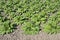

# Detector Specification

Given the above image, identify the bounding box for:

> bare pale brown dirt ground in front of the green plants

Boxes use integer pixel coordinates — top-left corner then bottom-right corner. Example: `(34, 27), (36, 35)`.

(0, 26), (60, 40)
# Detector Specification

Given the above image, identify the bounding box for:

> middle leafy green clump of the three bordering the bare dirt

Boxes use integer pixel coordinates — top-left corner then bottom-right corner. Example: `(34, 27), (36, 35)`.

(22, 22), (39, 35)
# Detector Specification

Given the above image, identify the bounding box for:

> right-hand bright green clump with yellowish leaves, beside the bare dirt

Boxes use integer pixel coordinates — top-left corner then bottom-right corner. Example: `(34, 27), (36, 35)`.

(43, 12), (60, 34)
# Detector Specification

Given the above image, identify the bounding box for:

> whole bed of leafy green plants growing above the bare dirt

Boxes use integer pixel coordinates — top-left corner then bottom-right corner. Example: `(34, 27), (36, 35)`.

(0, 0), (60, 34)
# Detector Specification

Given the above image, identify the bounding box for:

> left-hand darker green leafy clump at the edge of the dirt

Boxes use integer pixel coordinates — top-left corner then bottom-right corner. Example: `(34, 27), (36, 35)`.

(0, 17), (14, 34)
